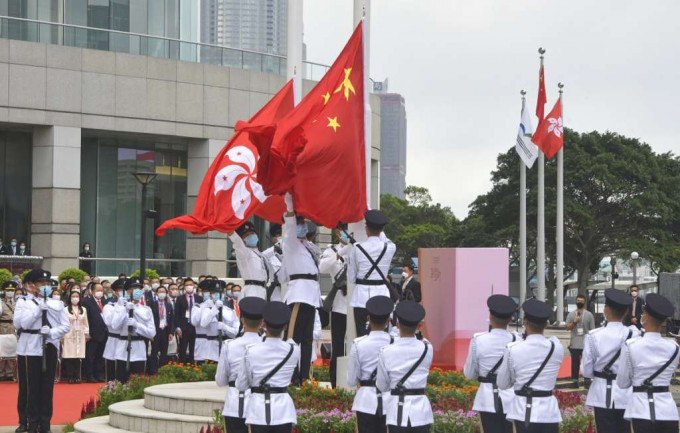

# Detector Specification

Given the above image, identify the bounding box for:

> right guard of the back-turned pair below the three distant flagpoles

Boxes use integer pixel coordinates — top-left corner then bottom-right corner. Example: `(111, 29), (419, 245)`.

(496, 299), (564, 433)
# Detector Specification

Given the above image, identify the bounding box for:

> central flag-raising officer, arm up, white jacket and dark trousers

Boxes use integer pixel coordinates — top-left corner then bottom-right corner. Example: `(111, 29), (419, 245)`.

(283, 193), (321, 383)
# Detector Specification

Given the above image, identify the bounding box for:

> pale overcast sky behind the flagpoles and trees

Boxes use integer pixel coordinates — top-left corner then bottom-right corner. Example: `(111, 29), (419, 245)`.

(304, 0), (680, 218)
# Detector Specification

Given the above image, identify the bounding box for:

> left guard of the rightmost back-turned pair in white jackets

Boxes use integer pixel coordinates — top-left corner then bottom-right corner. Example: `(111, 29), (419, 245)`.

(581, 289), (639, 433)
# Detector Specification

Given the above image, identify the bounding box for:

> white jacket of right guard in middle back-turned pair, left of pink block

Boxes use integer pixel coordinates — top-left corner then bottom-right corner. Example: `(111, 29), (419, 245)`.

(376, 337), (434, 427)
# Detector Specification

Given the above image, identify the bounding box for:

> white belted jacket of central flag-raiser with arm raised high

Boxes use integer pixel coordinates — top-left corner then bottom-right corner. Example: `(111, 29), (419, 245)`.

(282, 216), (321, 308)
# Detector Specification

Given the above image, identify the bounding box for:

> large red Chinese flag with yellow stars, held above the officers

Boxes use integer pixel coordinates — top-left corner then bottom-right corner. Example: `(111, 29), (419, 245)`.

(236, 24), (366, 227)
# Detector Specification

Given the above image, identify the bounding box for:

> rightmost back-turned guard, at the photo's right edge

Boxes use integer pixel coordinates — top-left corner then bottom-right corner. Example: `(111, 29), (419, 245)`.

(616, 293), (679, 433)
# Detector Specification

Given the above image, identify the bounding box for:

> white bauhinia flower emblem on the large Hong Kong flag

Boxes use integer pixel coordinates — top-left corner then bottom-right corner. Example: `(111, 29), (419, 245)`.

(214, 146), (267, 219)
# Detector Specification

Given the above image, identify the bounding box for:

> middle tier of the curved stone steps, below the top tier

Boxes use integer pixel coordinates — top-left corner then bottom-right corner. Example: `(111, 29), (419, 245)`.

(109, 400), (214, 433)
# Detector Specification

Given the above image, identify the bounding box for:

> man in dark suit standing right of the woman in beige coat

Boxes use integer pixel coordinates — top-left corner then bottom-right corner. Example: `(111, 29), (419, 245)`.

(82, 283), (108, 382)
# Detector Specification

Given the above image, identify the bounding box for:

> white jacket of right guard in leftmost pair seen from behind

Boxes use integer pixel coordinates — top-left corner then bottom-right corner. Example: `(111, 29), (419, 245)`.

(236, 338), (300, 425)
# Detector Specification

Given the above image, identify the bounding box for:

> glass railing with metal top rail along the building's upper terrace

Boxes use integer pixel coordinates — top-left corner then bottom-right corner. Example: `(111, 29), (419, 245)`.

(0, 15), (329, 81)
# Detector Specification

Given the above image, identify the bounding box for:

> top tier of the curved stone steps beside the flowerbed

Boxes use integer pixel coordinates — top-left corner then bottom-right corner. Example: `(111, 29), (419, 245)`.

(144, 382), (227, 417)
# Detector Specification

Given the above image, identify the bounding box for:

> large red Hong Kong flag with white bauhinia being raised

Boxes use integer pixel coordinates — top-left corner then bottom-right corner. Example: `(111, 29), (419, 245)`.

(156, 80), (293, 236)
